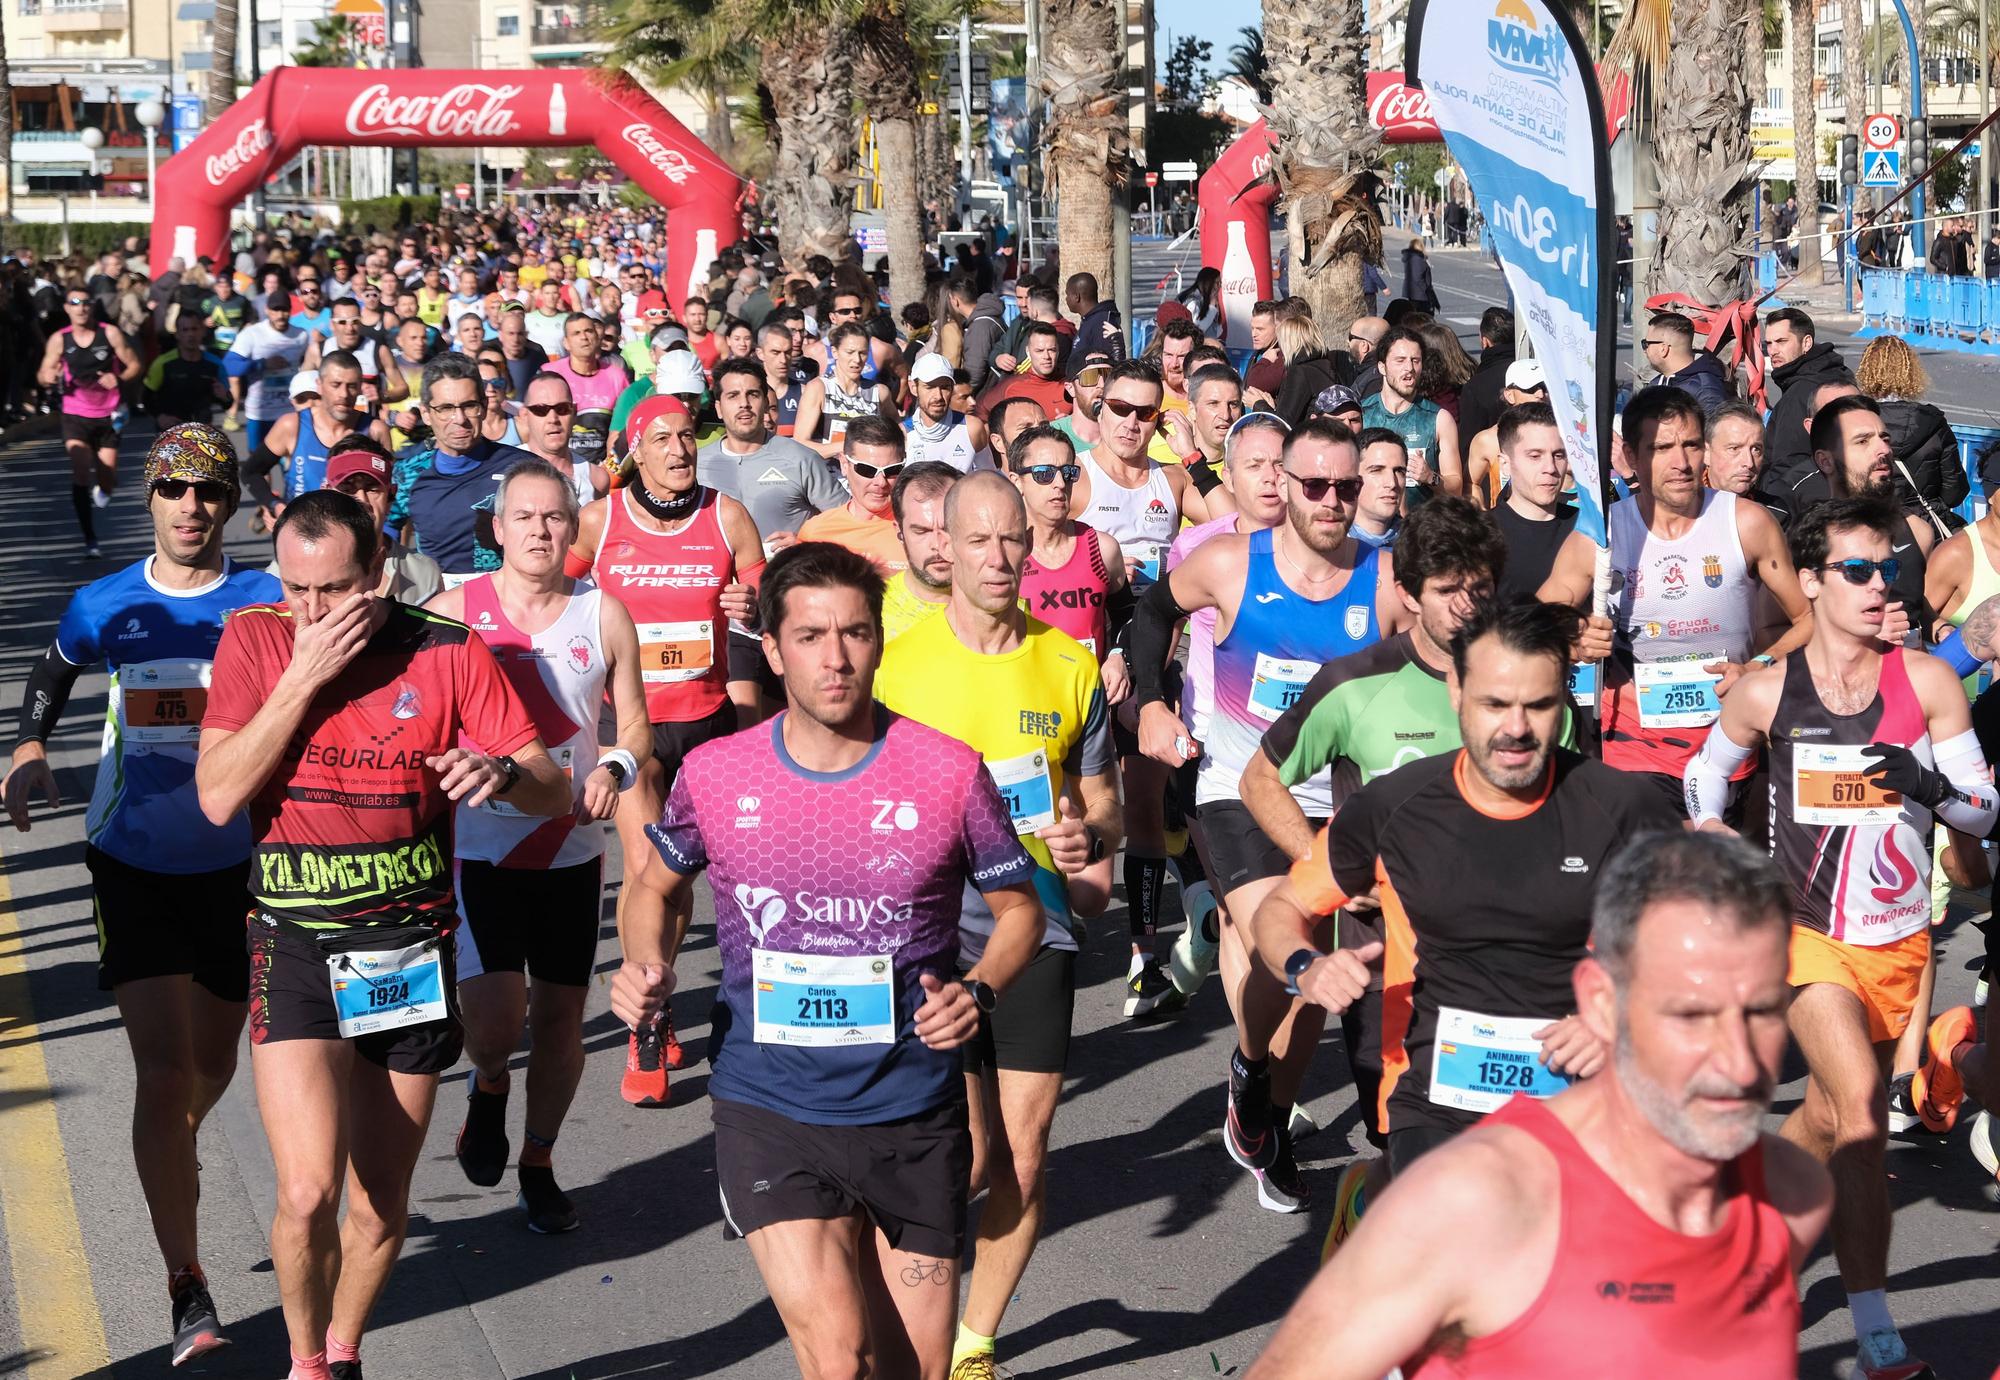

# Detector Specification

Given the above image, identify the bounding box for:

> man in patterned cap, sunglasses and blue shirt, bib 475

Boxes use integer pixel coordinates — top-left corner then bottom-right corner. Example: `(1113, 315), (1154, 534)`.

(4, 422), (280, 1366)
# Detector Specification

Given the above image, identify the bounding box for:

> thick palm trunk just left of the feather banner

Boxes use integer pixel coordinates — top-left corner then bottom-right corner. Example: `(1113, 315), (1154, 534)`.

(1264, 0), (1382, 340)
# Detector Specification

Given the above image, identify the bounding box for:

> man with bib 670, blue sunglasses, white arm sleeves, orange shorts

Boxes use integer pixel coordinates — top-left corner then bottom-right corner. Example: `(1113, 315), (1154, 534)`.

(1684, 494), (2000, 1380)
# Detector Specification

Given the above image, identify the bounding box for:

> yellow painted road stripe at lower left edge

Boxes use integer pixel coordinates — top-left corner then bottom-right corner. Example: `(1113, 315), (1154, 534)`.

(0, 844), (112, 1380)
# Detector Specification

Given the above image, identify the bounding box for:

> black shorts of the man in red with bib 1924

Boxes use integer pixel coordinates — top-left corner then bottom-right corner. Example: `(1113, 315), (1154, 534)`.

(250, 914), (466, 1074)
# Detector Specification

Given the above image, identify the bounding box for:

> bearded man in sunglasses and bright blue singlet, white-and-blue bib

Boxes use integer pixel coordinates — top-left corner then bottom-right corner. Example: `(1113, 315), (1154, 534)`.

(1130, 420), (1414, 1212)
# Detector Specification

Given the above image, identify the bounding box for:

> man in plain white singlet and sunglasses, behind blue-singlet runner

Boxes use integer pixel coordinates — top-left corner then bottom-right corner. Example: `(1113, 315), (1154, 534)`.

(1070, 360), (1194, 1018)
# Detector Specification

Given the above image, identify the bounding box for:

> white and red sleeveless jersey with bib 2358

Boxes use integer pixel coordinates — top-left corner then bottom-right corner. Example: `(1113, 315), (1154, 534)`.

(1604, 490), (1756, 776)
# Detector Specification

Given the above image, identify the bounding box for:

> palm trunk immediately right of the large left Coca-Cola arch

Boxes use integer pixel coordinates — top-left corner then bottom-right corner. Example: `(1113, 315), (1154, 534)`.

(760, 24), (856, 264)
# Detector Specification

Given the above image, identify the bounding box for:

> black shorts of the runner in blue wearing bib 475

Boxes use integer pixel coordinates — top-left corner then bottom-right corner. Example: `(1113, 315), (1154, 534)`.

(84, 844), (250, 1002)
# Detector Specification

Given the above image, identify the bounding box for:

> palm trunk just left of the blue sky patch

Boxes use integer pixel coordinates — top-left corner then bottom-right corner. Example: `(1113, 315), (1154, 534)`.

(1042, 0), (1132, 296)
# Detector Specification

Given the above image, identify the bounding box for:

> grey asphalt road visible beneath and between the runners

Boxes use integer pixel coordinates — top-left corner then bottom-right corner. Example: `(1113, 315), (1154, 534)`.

(0, 392), (2000, 1380)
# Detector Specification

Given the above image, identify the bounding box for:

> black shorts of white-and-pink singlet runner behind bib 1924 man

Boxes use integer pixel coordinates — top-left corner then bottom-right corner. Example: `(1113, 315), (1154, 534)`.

(458, 858), (604, 988)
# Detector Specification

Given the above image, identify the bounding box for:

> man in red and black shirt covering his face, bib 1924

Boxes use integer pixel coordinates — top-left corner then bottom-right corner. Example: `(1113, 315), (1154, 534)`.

(194, 490), (572, 1380)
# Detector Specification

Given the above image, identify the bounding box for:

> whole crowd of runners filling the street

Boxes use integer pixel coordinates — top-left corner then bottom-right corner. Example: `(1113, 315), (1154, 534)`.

(6, 212), (2000, 1380)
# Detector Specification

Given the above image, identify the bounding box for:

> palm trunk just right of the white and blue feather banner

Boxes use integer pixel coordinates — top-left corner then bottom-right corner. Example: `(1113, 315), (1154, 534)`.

(1646, 0), (1762, 306)
